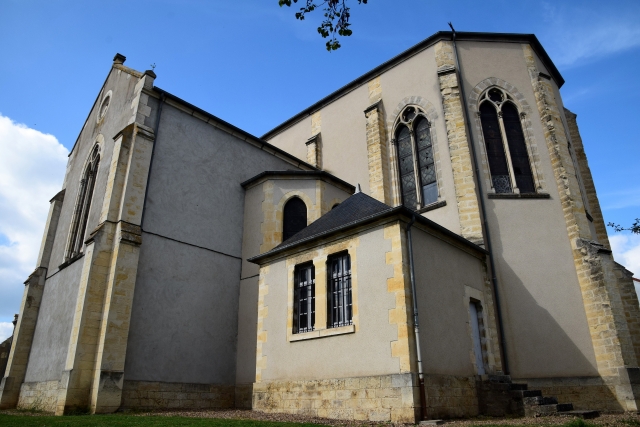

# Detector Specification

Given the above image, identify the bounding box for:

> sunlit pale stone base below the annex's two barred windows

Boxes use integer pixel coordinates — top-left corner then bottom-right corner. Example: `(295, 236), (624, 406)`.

(253, 373), (420, 423)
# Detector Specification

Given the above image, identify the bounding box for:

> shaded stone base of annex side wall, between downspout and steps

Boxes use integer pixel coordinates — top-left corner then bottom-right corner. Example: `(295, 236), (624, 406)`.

(424, 375), (479, 419)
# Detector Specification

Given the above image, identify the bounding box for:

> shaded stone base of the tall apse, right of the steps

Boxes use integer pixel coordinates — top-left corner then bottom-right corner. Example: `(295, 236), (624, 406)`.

(514, 377), (625, 412)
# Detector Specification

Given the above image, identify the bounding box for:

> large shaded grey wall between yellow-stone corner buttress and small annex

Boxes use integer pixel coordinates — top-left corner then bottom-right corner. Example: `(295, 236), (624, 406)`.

(123, 102), (304, 402)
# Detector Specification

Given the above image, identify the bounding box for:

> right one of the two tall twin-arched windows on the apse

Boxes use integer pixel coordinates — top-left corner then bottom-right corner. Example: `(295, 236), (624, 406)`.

(479, 88), (536, 193)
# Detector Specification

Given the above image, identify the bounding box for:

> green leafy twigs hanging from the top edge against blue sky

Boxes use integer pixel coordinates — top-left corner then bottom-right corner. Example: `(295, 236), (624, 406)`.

(278, 0), (368, 52)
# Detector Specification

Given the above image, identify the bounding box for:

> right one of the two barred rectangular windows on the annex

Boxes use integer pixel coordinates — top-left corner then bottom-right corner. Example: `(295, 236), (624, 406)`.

(327, 253), (353, 328)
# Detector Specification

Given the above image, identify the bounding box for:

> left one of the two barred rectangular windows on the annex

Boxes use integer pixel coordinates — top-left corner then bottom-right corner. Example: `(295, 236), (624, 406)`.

(293, 264), (316, 334)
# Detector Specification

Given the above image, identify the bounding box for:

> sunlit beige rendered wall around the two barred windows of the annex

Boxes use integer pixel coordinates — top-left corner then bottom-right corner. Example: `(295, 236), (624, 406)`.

(261, 227), (400, 382)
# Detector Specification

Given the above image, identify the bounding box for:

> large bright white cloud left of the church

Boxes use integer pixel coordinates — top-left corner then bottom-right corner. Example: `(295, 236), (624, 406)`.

(0, 114), (69, 320)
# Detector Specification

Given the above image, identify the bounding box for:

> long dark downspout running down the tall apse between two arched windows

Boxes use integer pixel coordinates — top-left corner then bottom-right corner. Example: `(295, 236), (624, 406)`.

(449, 22), (509, 375)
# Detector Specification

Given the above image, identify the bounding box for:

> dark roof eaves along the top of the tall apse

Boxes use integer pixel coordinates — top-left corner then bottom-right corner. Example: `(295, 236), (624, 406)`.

(261, 31), (564, 139)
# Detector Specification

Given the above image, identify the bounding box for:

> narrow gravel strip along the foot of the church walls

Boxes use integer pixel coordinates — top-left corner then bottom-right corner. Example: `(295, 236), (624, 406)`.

(0, 410), (640, 427)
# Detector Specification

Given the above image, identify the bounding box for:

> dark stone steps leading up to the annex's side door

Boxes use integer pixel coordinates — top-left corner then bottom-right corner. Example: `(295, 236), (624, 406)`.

(477, 375), (600, 419)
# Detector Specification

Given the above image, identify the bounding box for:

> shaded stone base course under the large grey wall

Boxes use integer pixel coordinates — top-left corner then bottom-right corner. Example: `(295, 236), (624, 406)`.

(121, 380), (236, 409)
